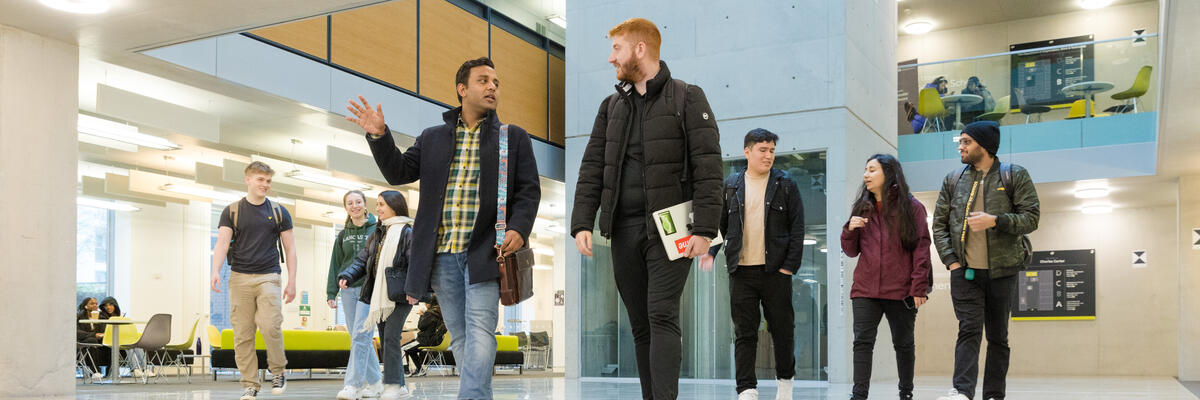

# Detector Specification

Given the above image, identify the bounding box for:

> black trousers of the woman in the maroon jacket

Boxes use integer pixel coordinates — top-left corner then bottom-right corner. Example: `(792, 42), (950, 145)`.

(850, 297), (917, 400)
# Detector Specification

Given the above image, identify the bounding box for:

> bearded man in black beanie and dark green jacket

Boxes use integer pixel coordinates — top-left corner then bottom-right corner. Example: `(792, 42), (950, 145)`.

(934, 121), (1040, 400)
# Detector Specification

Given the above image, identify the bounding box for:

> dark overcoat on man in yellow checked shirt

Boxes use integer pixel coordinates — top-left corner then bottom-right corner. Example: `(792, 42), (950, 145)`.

(367, 107), (541, 299)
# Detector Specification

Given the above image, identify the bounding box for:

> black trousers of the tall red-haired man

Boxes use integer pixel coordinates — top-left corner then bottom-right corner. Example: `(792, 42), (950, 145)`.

(612, 222), (691, 400)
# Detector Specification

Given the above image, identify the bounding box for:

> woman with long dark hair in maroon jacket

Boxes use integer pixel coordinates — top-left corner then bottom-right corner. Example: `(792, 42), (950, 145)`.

(841, 154), (931, 399)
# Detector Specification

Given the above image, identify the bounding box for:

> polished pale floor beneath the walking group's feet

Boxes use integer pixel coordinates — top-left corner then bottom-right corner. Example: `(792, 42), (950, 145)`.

(77, 374), (1200, 400)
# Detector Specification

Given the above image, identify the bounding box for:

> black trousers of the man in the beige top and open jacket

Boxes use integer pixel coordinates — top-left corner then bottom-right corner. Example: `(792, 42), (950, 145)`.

(730, 265), (796, 393)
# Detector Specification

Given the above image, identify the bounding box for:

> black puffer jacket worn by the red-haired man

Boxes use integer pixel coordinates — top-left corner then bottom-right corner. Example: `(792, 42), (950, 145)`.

(571, 61), (722, 238)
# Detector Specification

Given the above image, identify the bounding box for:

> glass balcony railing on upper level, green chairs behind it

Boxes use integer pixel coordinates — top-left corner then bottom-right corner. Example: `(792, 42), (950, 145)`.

(899, 34), (1159, 135)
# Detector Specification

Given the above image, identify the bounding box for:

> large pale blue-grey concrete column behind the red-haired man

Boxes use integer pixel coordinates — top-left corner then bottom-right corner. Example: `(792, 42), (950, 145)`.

(565, 0), (896, 382)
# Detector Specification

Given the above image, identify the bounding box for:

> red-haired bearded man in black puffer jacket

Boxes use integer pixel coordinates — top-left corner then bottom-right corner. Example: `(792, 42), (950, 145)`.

(571, 18), (721, 399)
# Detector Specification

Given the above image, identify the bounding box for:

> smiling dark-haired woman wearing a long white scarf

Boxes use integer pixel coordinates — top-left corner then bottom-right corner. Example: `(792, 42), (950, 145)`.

(337, 190), (416, 400)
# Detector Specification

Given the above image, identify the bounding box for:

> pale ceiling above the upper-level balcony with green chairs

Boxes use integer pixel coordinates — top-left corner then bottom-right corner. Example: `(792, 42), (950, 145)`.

(896, 0), (1154, 35)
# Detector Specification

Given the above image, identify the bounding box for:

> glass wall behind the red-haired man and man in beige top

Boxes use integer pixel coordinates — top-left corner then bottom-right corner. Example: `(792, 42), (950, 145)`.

(581, 151), (828, 380)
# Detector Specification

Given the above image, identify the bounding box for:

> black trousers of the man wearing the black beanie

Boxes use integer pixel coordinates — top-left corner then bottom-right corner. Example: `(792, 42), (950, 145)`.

(950, 264), (1016, 399)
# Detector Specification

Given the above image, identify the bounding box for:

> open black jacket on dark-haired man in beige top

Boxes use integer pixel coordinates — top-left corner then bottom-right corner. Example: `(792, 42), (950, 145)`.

(708, 168), (804, 273)
